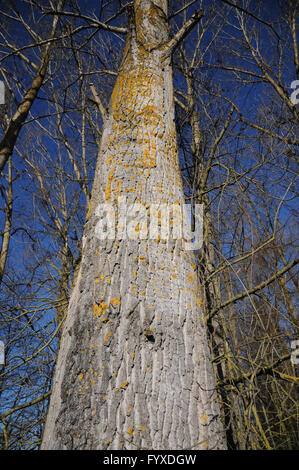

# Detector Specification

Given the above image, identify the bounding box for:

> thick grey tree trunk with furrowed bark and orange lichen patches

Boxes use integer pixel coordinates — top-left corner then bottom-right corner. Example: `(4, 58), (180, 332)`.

(42, 0), (225, 449)
